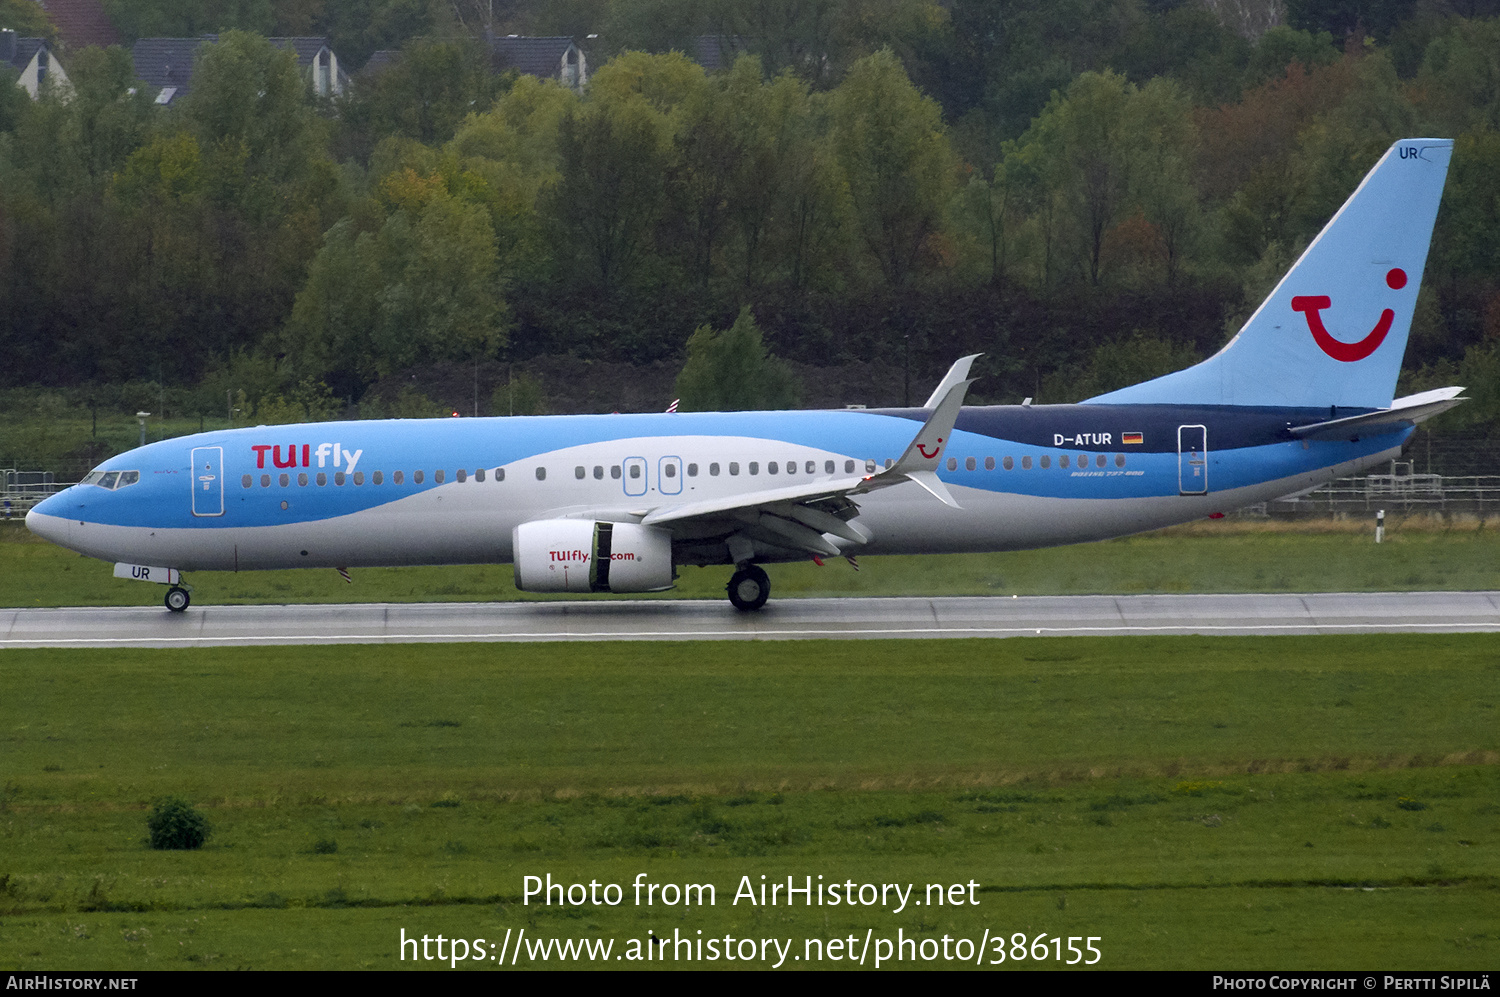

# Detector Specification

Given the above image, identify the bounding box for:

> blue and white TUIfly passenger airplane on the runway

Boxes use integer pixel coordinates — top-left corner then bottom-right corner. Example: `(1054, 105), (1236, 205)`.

(26, 138), (1464, 612)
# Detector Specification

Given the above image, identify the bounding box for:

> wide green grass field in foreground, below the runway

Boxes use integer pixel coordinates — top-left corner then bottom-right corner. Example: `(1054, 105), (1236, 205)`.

(0, 636), (1500, 969)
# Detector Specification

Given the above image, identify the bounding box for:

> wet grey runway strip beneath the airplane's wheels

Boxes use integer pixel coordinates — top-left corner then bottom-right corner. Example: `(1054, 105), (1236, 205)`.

(0, 592), (1500, 648)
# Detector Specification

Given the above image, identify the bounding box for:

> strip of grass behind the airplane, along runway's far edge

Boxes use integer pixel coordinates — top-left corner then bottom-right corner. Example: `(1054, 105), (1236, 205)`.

(0, 517), (1500, 606)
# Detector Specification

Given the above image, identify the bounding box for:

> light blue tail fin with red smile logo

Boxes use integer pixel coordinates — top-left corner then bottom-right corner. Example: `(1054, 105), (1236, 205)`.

(1089, 138), (1454, 408)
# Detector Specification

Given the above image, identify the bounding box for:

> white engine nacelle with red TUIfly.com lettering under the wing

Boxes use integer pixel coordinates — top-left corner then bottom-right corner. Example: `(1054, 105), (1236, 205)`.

(512, 519), (672, 592)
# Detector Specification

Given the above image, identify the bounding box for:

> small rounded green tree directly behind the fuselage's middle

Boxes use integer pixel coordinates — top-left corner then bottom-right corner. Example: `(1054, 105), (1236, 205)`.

(677, 306), (800, 412)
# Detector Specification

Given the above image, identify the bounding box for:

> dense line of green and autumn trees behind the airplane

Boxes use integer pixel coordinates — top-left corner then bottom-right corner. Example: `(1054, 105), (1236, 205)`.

(0, 0), (1500, 440)
